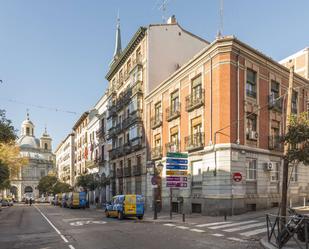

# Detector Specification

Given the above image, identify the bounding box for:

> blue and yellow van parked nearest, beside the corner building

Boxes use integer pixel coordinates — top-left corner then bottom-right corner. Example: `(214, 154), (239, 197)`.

(105, 195), (144, 220)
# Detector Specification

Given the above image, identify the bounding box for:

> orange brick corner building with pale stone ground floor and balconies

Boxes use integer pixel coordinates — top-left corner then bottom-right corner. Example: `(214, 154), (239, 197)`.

(145, 36), (309, 214)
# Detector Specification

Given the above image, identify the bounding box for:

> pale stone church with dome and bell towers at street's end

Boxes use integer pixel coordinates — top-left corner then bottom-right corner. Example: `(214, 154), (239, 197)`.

(10, 113), (55, 201)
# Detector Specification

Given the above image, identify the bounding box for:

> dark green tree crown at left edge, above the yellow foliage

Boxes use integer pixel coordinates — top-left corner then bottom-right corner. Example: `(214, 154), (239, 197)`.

(0, 110), (17, 143)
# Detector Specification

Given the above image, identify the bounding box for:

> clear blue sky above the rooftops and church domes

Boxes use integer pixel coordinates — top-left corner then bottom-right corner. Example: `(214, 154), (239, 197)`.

(0, 0), (309, 148)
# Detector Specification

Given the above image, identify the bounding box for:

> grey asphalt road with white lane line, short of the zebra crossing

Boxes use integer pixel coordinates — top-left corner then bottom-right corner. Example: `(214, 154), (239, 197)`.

(0, 205), (261, 249)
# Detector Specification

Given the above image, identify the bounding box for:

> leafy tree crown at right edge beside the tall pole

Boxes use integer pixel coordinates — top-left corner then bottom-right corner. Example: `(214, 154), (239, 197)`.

(284, 112), (309, 165)
